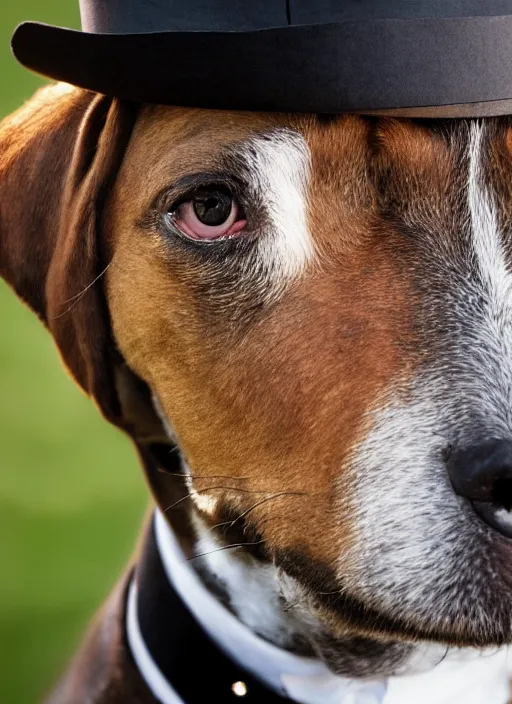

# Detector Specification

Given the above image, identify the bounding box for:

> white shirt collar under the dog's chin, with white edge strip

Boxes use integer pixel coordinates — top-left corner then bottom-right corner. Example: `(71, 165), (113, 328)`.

(127, 512), (508, 704)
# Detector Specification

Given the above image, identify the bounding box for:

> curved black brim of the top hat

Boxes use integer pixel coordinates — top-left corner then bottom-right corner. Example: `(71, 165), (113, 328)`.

(12, 15), (512, 117)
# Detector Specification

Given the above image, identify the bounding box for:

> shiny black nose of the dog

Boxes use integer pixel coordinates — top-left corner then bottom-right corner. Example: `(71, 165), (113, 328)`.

(446, 439), (512, 538)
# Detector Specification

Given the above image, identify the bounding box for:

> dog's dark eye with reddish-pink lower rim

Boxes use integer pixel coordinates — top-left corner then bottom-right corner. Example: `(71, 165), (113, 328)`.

(172, 186), (246, 240)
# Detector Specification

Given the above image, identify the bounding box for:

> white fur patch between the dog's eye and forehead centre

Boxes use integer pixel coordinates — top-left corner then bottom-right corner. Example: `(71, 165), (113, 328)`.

(243, 130), (314, 280)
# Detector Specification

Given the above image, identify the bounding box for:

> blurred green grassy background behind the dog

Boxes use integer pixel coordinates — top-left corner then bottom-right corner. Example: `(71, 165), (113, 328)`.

(0, 0), (148, 704)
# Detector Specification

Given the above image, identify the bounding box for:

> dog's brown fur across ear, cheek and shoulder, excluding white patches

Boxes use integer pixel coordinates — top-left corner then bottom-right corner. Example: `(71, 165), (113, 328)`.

(0, 88), (510, 704)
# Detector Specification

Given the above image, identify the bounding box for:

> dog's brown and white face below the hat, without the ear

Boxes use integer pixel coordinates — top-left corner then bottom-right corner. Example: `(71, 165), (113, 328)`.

(3, 86), (512, 672)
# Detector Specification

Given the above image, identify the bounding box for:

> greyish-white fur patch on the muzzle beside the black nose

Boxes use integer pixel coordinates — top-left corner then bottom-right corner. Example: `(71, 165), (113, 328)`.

(339, 384), (464, 636)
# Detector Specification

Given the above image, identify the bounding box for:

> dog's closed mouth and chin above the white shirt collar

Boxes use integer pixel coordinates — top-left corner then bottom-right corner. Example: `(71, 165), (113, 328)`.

(281, 541), (512, 677)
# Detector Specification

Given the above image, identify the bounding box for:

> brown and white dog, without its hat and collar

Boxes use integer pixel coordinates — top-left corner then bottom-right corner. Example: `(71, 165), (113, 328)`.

(0, 86), (512, 704)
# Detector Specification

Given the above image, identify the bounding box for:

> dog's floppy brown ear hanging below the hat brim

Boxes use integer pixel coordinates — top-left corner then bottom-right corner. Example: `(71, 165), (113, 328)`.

(0, 86), (135, 426)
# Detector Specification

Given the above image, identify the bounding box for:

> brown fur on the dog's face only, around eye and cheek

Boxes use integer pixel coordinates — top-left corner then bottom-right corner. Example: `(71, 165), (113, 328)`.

(102, 108), (418, 576)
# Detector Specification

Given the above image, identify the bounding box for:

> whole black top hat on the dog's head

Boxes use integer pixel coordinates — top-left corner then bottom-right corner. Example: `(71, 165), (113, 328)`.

(12, 0), (512, 117)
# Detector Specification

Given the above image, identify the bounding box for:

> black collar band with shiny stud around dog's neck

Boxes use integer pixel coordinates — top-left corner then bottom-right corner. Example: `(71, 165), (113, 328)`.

(128, 521), (292, 704)
